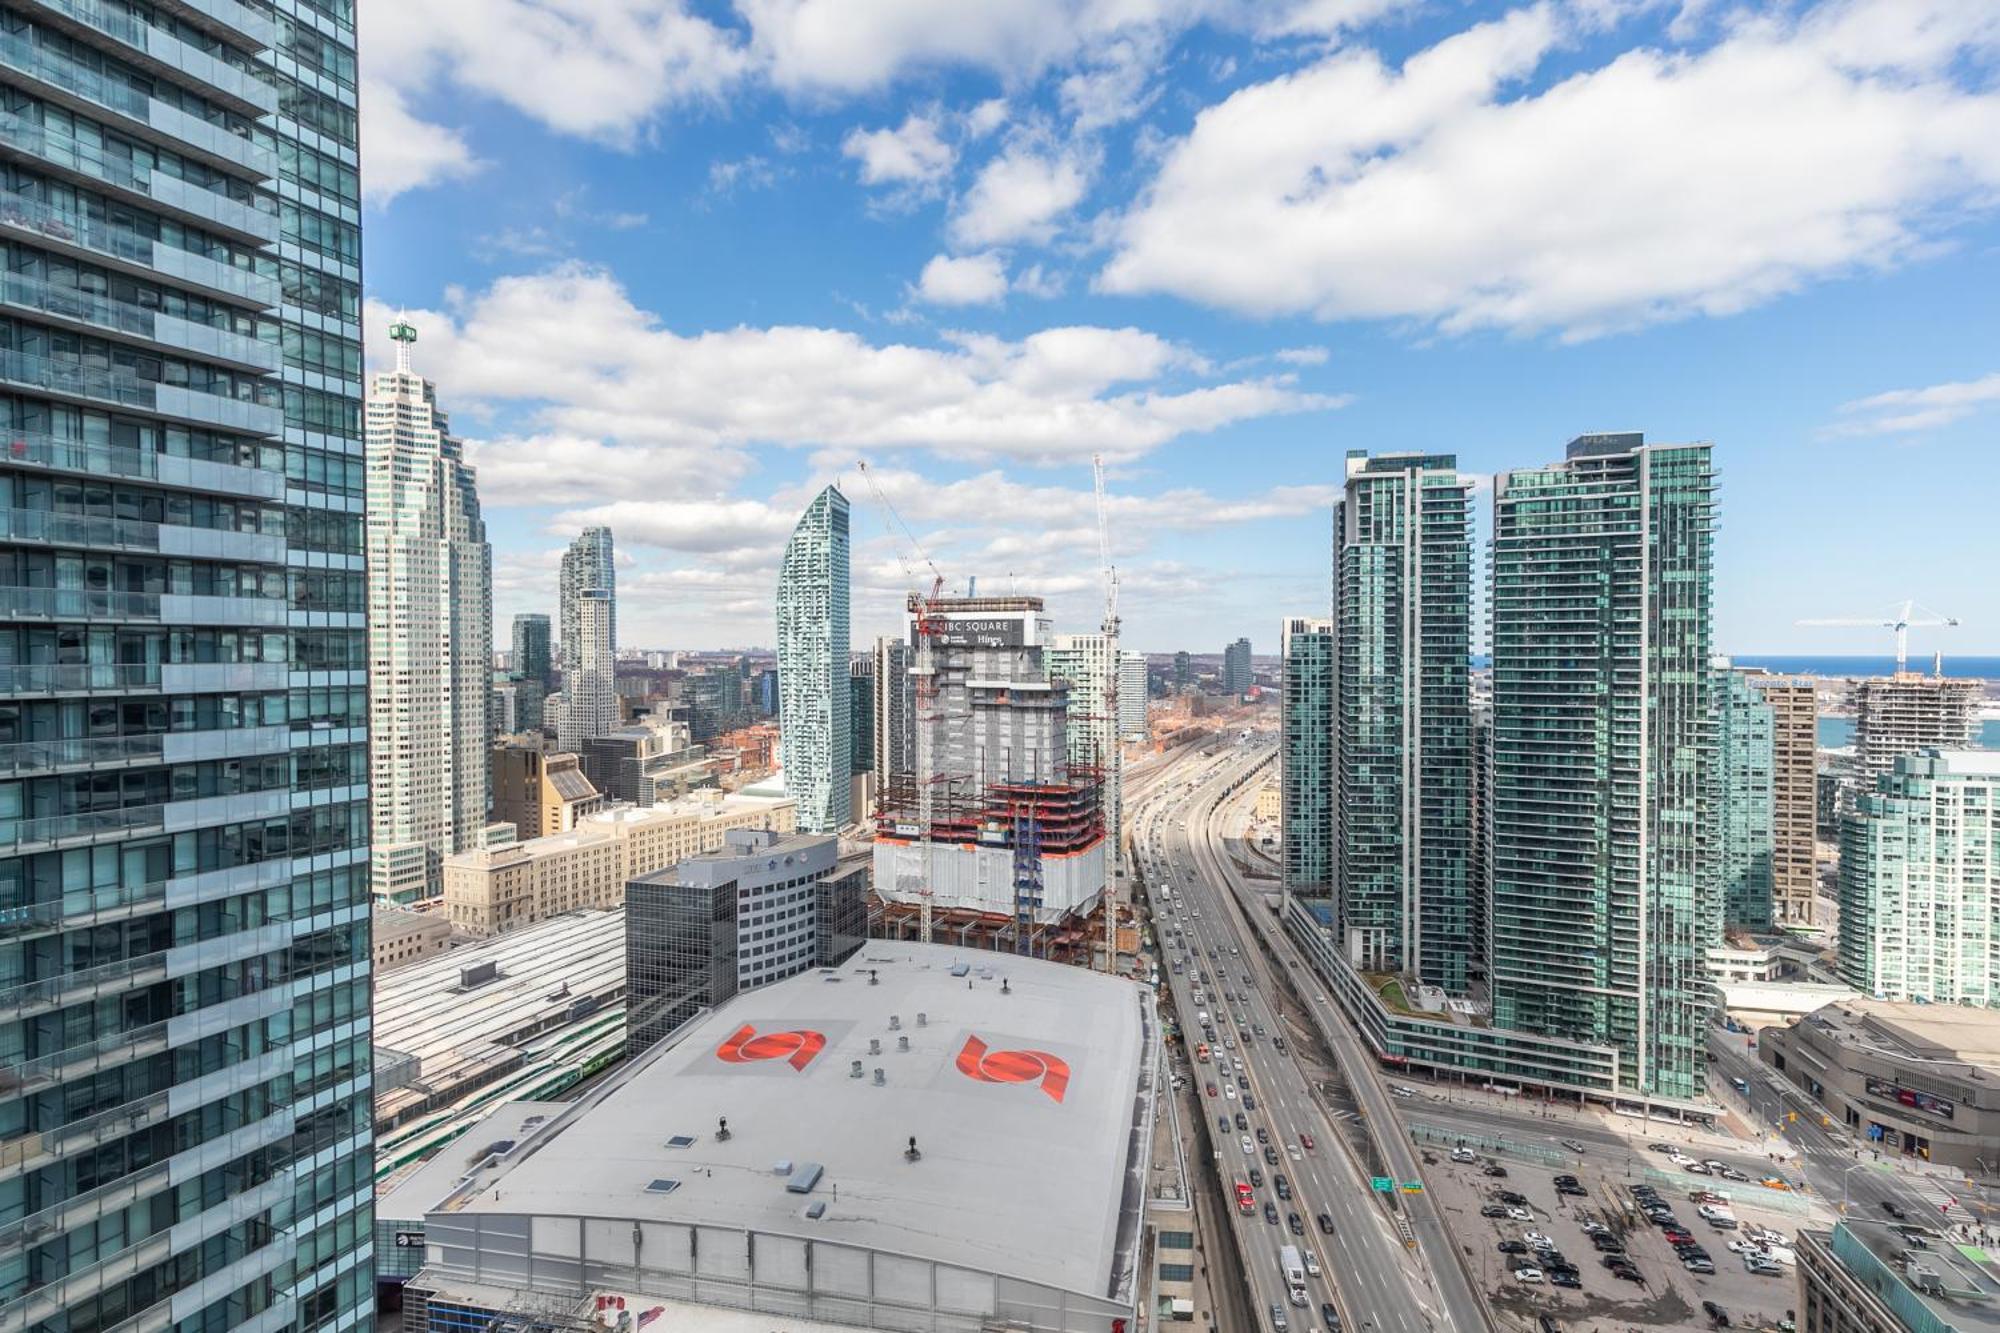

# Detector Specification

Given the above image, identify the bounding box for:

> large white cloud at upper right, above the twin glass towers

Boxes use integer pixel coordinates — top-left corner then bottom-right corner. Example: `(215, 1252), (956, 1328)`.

(1100, 0), (2000, 336)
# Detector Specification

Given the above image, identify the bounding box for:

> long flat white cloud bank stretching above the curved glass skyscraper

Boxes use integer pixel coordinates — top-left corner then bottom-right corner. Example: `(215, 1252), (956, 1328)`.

(366, 264), (1342, 482)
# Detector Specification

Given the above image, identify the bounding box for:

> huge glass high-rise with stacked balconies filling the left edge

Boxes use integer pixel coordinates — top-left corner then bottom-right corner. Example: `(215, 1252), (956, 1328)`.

(0, 0), (374, 1333)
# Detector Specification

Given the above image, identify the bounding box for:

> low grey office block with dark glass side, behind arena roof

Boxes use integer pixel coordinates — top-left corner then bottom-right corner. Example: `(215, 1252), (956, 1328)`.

(626, 829), (868, 1053)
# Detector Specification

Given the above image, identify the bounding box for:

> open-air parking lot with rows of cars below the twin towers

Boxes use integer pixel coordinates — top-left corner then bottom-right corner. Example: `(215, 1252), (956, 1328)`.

(1420, 1139), (1810, 1333)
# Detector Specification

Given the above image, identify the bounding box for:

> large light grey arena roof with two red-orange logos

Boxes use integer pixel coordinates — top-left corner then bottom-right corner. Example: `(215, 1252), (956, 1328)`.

(442, 941), (1156, 1299)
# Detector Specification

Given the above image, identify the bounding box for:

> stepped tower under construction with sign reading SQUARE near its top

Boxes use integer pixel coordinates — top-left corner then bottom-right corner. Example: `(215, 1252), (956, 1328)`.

(874, 594), (1106, 955)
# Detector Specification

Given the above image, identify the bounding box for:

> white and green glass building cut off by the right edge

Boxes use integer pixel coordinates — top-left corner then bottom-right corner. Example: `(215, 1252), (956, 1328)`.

(1840, 751), (2000, 1007)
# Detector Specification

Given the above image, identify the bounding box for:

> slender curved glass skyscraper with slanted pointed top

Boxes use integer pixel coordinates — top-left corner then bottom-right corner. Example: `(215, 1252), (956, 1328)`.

(778, 486), (854, 833)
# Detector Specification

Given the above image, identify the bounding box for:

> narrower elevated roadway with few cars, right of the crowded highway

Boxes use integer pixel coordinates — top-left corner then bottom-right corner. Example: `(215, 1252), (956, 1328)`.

(1190, 747), (1492, 1333)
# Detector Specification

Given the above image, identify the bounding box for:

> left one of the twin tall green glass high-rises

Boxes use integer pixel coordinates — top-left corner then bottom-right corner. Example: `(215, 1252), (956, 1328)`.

(1332, 452), (1476, 995)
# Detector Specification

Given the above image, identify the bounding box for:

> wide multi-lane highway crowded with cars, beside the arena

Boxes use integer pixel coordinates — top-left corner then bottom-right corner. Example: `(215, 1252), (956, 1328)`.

(1128, 747), (1448, 1333)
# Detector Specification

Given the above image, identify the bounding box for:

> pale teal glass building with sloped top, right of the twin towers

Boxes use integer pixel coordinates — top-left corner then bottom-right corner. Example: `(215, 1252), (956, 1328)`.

(1702, 658), (1778, 928)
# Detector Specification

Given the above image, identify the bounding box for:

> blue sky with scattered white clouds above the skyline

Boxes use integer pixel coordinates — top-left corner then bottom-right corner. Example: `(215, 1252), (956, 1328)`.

(358, 0), (2000, 654)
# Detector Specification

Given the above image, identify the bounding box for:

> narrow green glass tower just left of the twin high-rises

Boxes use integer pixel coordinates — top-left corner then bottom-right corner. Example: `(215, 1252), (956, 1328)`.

(1278, 616), (1336, 904)
